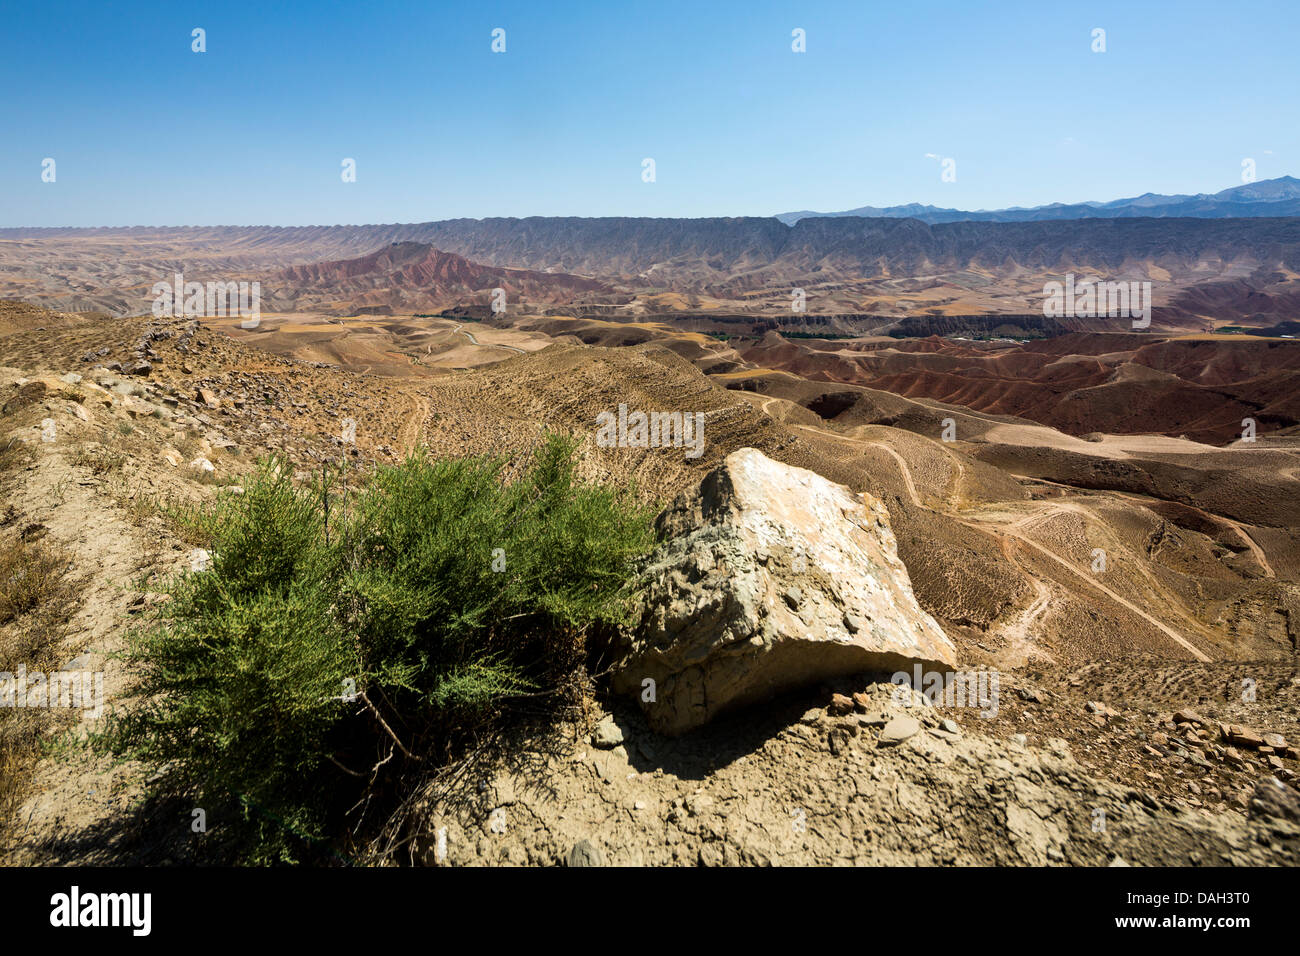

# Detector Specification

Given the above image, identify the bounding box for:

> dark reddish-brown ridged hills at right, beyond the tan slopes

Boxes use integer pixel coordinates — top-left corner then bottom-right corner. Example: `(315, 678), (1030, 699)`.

(736, 333), (1300, 444)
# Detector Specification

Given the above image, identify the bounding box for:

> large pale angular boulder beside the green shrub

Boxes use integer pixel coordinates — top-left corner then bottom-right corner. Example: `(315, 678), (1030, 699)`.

(614, 449), (957, 734)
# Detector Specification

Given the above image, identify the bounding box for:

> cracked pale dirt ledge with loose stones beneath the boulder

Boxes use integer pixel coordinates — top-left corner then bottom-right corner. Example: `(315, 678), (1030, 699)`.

(411, 679), (1300, 866)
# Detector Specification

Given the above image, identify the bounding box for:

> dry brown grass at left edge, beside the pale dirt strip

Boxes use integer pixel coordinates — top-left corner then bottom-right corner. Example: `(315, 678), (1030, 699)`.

(0, 535), (75, 835)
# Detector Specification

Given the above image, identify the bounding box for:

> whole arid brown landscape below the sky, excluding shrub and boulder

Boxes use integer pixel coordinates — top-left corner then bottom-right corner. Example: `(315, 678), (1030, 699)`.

(0, 205), (1300, 865)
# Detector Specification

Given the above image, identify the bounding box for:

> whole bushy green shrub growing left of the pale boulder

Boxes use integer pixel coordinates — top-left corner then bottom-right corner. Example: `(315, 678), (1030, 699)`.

(96, 436), (653, 862)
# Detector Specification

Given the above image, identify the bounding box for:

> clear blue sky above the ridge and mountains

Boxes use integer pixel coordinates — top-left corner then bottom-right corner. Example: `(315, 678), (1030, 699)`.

(0, 0), (1300, 226)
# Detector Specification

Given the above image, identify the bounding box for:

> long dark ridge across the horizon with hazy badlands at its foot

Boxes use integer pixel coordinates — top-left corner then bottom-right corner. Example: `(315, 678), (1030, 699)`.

(10, 216), (1300, 327)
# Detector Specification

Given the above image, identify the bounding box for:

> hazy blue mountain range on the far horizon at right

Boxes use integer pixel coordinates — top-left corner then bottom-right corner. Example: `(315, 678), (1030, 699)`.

(776, 176), (1300, 225)
